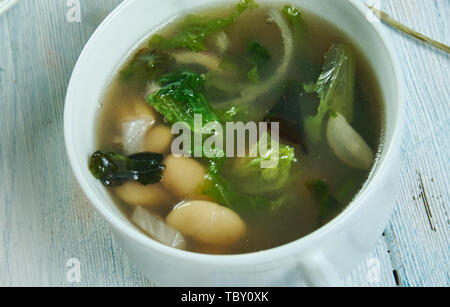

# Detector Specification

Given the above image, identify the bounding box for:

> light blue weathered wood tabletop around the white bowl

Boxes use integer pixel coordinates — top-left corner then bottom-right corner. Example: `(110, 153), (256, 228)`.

(0, 0), (450, 286)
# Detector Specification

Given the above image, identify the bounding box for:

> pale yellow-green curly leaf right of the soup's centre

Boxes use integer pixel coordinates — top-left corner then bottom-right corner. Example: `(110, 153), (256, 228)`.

(233, 134), (296, 194)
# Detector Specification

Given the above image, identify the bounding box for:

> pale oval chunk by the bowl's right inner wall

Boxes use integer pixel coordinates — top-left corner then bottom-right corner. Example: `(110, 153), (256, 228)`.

(327, 113), (375, 170)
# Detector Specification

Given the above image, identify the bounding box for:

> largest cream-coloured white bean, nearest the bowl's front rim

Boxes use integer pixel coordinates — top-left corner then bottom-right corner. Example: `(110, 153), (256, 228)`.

(167, 201), (246, 247)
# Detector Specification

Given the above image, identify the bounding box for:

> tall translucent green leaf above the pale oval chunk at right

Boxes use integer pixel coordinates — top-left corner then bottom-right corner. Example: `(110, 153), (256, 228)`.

(305, 44), (356, 142)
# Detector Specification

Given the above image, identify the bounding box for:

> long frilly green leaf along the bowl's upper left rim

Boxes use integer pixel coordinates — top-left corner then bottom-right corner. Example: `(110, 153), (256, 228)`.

(149, 0), (257, 51)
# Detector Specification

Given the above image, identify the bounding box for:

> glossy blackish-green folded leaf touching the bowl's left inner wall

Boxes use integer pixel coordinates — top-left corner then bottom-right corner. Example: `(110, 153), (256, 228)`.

(89, 150), (165, 186)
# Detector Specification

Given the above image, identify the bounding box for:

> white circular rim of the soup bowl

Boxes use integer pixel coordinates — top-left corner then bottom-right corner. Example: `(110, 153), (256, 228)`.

(64, 0), (404, 267)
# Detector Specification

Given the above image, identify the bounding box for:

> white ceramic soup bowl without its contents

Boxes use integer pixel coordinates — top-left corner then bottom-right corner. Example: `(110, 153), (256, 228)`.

(64, 0), (404, 286)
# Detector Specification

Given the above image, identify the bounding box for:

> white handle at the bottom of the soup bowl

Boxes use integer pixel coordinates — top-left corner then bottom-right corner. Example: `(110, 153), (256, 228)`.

(300, 251), (344, 287)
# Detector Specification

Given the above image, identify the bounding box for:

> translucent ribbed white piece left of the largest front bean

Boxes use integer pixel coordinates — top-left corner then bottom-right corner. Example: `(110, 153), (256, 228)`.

(131, 207), (186, 249)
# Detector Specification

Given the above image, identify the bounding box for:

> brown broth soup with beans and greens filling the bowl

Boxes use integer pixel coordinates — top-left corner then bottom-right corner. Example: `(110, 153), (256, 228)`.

(89, 0), (383, 254)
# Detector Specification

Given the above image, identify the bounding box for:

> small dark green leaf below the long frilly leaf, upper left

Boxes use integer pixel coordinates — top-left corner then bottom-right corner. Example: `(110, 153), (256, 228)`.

(120, 48), (169, 81)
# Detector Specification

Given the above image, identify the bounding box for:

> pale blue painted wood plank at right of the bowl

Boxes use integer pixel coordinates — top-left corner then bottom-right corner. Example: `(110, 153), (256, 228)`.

(358, 0), (450, 286)
